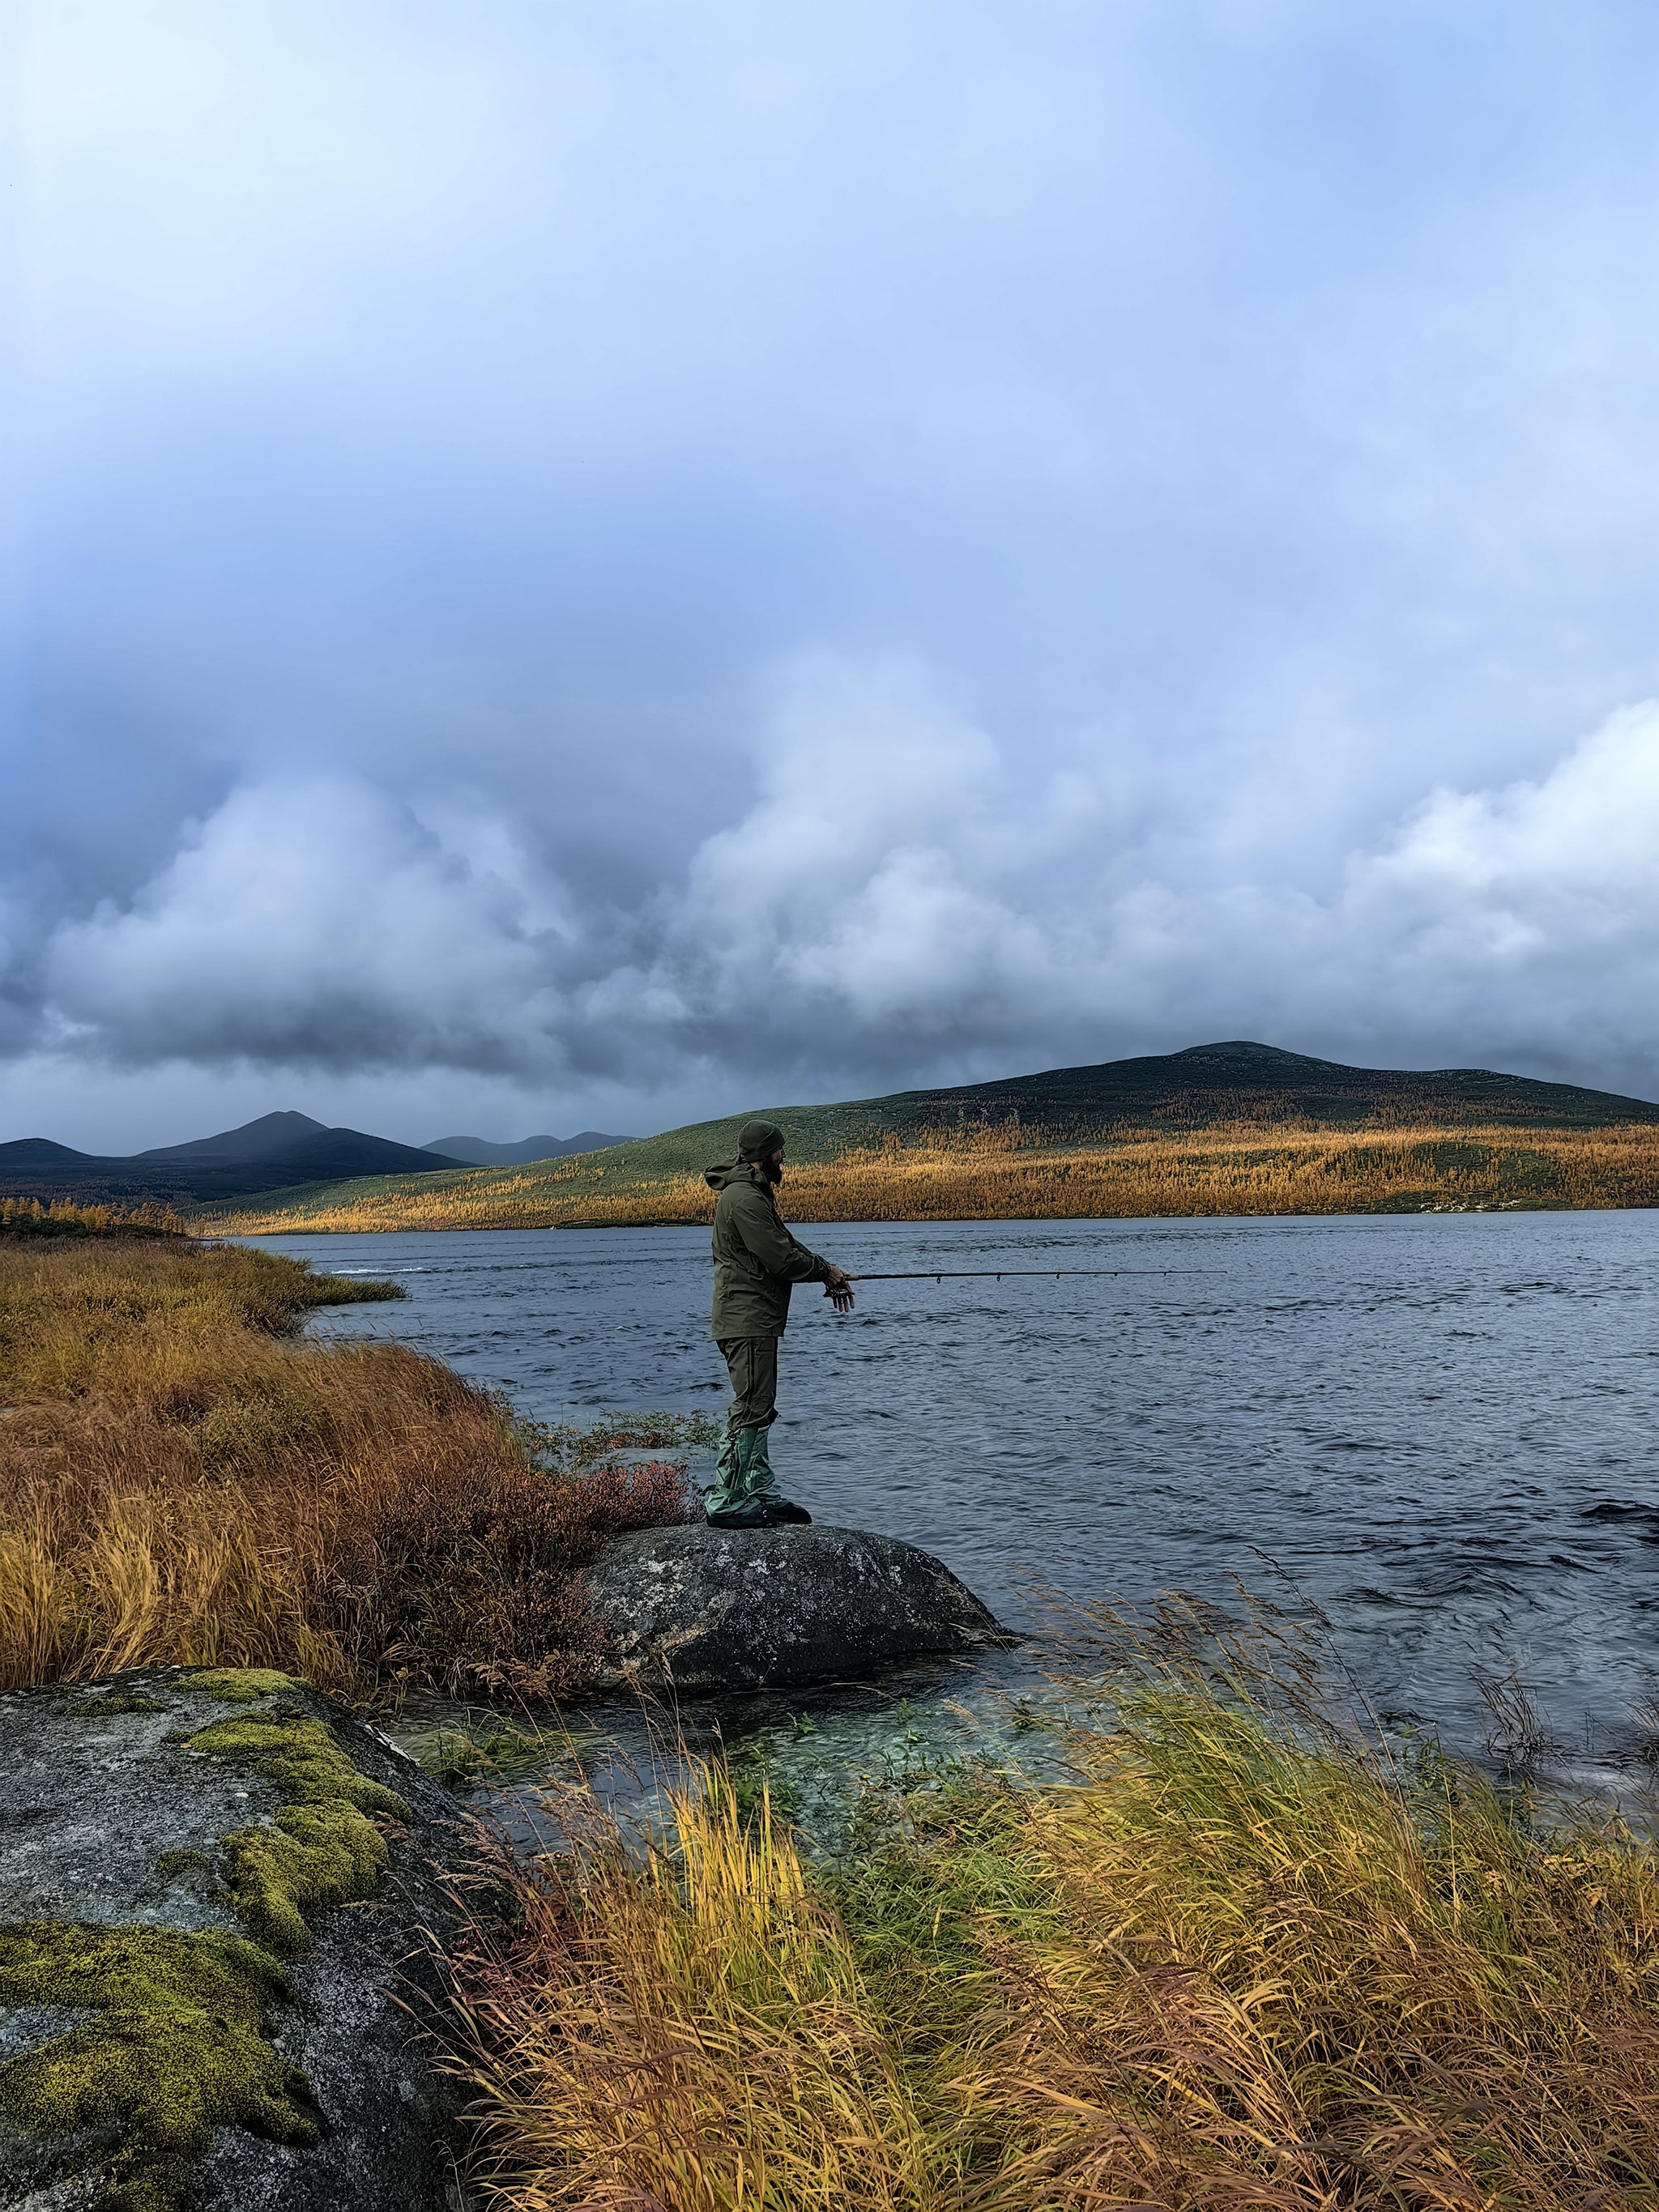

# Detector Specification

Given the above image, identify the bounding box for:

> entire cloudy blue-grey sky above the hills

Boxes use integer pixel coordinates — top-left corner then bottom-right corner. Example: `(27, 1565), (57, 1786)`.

(0, 0), (1659, 1150)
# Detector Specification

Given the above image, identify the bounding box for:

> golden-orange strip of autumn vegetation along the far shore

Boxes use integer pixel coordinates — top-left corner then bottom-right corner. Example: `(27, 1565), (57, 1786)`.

(203, 1123), (1659, 1237)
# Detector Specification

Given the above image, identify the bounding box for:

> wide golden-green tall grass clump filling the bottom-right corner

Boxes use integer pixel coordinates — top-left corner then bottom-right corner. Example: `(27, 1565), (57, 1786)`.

(928, 1619), (1659, 2212)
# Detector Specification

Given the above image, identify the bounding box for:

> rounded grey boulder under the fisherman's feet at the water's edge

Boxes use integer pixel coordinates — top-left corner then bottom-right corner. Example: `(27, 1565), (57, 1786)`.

(584, 1524), (1015, 1690)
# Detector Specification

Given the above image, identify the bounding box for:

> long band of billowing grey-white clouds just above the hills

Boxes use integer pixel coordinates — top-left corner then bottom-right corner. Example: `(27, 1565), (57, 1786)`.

(32, 662), (1659, 1086)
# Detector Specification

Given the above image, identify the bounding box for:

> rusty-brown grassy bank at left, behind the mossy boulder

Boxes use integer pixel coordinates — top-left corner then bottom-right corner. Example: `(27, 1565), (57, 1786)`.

(0, 1237), (698, 1698)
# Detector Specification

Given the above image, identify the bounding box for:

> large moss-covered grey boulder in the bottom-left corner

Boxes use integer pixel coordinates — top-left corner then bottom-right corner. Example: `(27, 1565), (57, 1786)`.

(0, 1668), (463, 2212)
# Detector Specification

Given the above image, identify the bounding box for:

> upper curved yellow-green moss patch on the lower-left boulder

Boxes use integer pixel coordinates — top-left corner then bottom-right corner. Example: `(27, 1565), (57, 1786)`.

(179, 1706), (412, 1955)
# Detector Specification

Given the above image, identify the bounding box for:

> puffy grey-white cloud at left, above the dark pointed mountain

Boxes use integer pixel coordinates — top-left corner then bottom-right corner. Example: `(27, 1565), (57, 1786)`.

(46, 778), (569, 1073)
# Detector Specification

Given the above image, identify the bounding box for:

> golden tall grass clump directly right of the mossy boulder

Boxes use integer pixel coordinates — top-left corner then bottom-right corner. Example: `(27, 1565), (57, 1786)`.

(454, 1770), (927, 2212)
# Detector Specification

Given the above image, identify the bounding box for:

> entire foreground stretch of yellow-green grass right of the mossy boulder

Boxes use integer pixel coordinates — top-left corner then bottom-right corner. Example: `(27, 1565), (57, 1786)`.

(456, 1617), (1659, 2212)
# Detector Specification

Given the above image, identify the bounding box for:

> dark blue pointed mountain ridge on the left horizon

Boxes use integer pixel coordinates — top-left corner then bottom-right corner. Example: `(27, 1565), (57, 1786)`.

(0, 1113), (467, 1205)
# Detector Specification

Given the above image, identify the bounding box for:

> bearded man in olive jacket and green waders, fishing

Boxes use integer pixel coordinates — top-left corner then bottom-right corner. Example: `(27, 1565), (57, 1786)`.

(706, 1122), (851, 1528)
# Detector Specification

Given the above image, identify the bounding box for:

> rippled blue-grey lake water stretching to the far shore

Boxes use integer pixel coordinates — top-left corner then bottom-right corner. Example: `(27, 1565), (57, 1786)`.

(243, 1192), (1659, 1779)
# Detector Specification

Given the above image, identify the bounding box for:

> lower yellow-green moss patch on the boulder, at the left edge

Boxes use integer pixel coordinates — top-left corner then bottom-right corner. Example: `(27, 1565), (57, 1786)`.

(0, 1920), (316, 2212)
